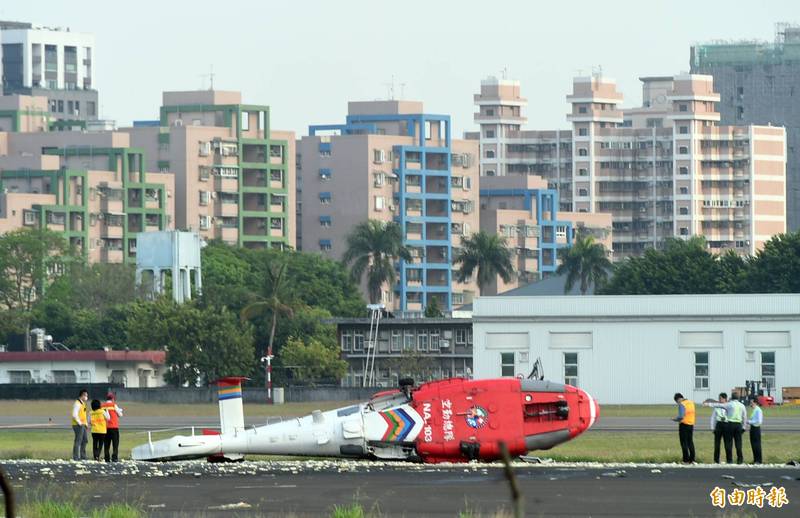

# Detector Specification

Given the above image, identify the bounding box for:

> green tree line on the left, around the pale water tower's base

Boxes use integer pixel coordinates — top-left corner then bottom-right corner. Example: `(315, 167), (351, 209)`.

(0, 229), (365, 386)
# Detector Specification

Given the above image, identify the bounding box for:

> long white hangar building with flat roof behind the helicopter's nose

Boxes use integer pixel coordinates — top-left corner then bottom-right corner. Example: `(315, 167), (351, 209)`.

(473, 290), (800, 404)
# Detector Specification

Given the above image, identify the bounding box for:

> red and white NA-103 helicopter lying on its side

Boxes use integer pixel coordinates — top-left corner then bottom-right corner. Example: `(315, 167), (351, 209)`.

(132, 377), (600, 463)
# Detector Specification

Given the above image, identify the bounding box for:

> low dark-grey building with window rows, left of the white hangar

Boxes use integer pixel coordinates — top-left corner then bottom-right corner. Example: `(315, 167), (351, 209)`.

(334, 318), (472, 387)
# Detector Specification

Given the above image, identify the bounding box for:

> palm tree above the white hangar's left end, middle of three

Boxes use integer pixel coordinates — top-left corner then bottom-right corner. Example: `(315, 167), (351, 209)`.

(453, 230), (514, 292)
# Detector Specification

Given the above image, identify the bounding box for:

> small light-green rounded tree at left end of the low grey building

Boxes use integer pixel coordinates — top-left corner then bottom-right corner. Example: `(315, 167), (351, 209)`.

(281, 338), (347, 383)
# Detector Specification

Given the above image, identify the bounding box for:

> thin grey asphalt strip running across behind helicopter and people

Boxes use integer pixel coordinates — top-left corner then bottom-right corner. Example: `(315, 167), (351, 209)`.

(0, 412), (800, 432)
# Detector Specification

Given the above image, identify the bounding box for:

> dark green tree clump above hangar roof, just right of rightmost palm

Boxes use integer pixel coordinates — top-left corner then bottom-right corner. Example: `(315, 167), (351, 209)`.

(599, 236), (720, 295)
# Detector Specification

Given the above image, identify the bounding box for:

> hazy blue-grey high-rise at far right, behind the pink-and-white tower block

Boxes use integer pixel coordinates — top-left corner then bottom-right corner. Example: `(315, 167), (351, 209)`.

(690, 23), (800, 231)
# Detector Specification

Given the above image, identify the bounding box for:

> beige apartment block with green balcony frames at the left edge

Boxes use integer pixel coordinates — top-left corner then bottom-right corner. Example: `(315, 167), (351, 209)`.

(0, 123), (174, 263)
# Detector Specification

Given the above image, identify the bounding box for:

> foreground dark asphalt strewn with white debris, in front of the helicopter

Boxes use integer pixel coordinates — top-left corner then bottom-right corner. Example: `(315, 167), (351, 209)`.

(4, 461), (800, 518)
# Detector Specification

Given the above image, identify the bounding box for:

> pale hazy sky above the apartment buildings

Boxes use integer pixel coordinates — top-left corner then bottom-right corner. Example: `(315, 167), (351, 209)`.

(0, 0), (800, 136)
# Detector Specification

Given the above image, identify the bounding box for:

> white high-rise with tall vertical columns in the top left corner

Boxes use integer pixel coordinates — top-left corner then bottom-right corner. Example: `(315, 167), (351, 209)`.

(0, 21), (99, 126)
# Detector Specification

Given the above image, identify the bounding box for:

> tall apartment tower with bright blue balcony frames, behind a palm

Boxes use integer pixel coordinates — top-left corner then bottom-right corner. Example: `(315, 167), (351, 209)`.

(297, 100), (479, 314)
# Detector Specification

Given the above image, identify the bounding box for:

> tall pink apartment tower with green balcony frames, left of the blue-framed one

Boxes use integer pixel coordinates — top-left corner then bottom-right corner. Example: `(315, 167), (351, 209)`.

(122, 90), (295, 249)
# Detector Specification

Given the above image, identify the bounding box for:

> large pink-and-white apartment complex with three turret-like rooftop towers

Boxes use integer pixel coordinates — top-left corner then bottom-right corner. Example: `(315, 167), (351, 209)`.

(468, 74), (786, 260)
